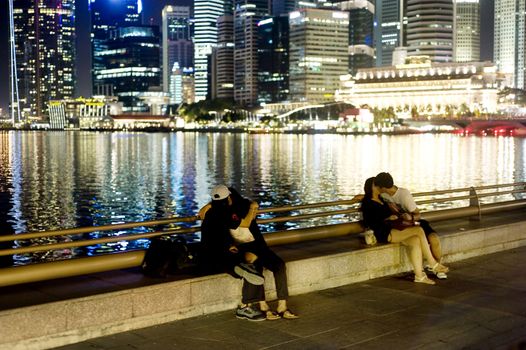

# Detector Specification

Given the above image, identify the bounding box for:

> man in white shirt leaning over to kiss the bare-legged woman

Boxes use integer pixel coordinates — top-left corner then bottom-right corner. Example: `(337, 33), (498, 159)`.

(374, 172), (447, 279)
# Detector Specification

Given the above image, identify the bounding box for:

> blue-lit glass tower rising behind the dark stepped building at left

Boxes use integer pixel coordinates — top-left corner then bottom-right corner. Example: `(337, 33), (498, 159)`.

(89, 0), (142, 96)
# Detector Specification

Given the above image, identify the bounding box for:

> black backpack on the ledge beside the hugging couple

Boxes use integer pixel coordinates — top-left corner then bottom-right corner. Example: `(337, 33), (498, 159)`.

(142, 236), (194, 277)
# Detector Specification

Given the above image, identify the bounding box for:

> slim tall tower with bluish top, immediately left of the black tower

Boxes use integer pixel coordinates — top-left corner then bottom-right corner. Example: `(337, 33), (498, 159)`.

(234, 0), (269, 106)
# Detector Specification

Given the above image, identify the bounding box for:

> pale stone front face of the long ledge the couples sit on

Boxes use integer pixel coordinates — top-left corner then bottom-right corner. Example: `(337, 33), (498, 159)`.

(0, 222), (526, 349)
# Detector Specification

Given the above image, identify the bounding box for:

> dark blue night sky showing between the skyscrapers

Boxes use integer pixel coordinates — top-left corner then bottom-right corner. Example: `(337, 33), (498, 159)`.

(0, 0), (494, 112)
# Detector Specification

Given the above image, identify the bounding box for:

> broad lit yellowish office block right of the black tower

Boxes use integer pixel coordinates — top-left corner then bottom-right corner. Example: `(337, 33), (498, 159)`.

(289, 9), (349, 103)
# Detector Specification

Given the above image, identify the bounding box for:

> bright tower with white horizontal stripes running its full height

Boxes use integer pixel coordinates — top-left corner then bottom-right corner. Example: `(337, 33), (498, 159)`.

(194, 0), (232, 101)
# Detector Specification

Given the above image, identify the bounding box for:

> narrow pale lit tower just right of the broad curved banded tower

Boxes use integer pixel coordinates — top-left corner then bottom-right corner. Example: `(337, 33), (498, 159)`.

(455, 0), (480, 62)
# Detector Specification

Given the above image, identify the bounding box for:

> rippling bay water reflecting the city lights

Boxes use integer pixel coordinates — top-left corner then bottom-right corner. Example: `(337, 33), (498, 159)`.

(0, 131), (526, 262)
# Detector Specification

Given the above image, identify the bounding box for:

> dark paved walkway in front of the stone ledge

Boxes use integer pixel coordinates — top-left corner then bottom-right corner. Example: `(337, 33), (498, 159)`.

(56, 247), (526, 350)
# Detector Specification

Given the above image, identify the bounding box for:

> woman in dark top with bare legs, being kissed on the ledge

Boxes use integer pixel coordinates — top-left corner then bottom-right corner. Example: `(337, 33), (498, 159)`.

(361, 177), (449, 285)
